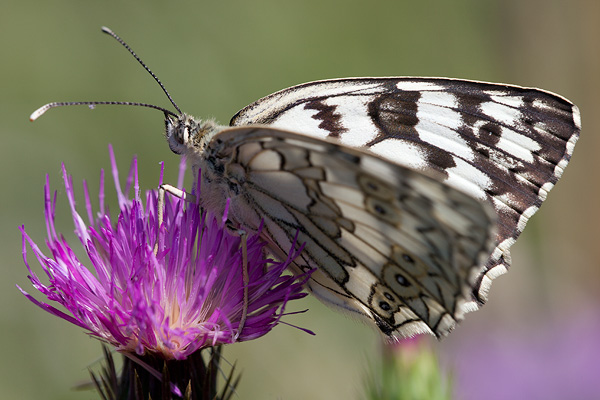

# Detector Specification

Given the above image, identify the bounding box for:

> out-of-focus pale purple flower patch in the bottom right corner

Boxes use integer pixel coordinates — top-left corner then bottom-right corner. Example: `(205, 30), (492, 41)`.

(445, 307), (600, 400)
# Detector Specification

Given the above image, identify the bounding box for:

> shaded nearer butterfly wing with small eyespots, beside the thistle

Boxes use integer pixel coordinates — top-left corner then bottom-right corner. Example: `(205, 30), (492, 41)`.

(203, 126), (495, 337)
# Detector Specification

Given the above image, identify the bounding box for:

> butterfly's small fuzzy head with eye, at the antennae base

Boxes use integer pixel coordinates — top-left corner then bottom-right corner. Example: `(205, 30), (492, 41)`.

(165, 114), (218, 154)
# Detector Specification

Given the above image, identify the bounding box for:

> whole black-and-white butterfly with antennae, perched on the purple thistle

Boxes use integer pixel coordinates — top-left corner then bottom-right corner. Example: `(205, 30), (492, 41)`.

(31, 28), (581, 340)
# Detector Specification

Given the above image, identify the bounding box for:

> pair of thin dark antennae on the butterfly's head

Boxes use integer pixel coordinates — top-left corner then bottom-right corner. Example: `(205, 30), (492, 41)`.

(29, 26), (182, 121)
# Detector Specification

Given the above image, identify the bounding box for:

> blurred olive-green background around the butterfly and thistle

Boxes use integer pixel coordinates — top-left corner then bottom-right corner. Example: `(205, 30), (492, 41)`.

(0, 0), (600, 399)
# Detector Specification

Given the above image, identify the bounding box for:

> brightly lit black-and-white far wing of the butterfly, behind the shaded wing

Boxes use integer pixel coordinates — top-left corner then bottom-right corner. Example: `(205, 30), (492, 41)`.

(231, 77), (581, 303)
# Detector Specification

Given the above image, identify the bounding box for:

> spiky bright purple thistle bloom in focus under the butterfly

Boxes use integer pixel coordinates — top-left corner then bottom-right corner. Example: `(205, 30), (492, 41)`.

(19, 148), (308, 360)
